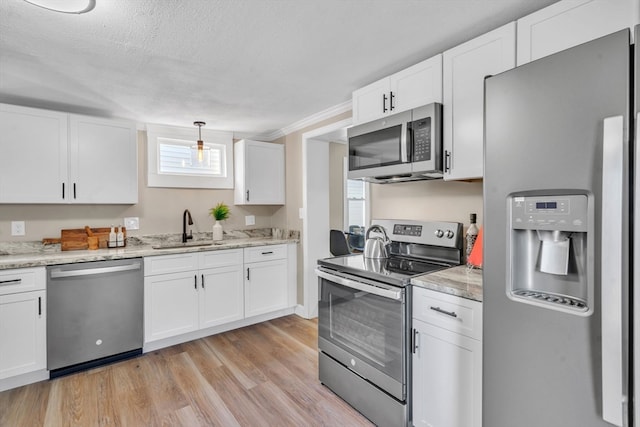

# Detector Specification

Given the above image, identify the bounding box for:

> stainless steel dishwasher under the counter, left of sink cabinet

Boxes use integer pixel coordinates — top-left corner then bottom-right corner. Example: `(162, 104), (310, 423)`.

(47, 258), (144, 378)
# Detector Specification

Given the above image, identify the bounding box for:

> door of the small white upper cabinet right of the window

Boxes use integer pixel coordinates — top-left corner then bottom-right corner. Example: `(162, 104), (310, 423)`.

(236, 141), (285, 205)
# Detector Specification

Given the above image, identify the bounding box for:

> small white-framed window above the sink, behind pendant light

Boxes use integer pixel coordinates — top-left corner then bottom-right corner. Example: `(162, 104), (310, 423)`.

(147, 125), (233, 188)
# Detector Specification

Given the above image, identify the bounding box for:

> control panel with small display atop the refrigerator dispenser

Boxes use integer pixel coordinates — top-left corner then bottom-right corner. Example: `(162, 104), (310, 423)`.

(510, 195), (588, 231)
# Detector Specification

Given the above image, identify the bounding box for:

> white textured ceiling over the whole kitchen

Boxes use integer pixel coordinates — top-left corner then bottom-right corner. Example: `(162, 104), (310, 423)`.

(0, 0), (556, 137)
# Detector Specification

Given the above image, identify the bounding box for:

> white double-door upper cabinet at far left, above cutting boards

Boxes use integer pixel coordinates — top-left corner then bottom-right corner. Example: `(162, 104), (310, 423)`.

(0, 104), (138, 204)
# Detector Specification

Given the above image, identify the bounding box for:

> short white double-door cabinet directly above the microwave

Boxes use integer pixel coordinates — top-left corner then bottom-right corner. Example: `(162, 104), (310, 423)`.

(352, 55), (442, 125)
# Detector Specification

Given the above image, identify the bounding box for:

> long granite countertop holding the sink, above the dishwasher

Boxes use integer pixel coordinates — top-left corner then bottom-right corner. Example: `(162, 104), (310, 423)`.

(0, 231), (299, 270)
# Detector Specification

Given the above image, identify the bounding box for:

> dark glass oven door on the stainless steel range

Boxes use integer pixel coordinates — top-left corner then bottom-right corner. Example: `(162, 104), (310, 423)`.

(319, 280), (404, 378)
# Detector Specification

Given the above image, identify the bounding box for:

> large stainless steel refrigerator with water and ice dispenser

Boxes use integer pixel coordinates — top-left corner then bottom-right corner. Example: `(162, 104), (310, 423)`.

(482, 30), (640, 427)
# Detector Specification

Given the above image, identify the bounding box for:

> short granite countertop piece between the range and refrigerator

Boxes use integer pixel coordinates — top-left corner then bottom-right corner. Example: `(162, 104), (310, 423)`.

(411, 265), (482, 302)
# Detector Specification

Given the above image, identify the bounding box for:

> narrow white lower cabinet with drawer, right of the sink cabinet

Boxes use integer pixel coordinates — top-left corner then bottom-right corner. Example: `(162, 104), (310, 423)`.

(244, 245), (289, 317)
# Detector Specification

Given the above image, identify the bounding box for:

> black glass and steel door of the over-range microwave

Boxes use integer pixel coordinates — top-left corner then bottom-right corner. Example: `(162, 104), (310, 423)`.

(347, 111), (412, 179)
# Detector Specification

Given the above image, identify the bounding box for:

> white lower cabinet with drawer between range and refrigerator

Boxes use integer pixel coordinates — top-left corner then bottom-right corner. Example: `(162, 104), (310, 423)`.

(412, 286), (482, 427)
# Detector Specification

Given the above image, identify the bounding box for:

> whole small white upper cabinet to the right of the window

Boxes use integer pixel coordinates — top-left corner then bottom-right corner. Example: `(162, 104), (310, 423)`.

(233, 139), (285, 205)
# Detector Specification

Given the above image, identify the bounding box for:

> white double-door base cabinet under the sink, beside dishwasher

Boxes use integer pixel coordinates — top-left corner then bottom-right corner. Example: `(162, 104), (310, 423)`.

(144, 249), (244, 342)
